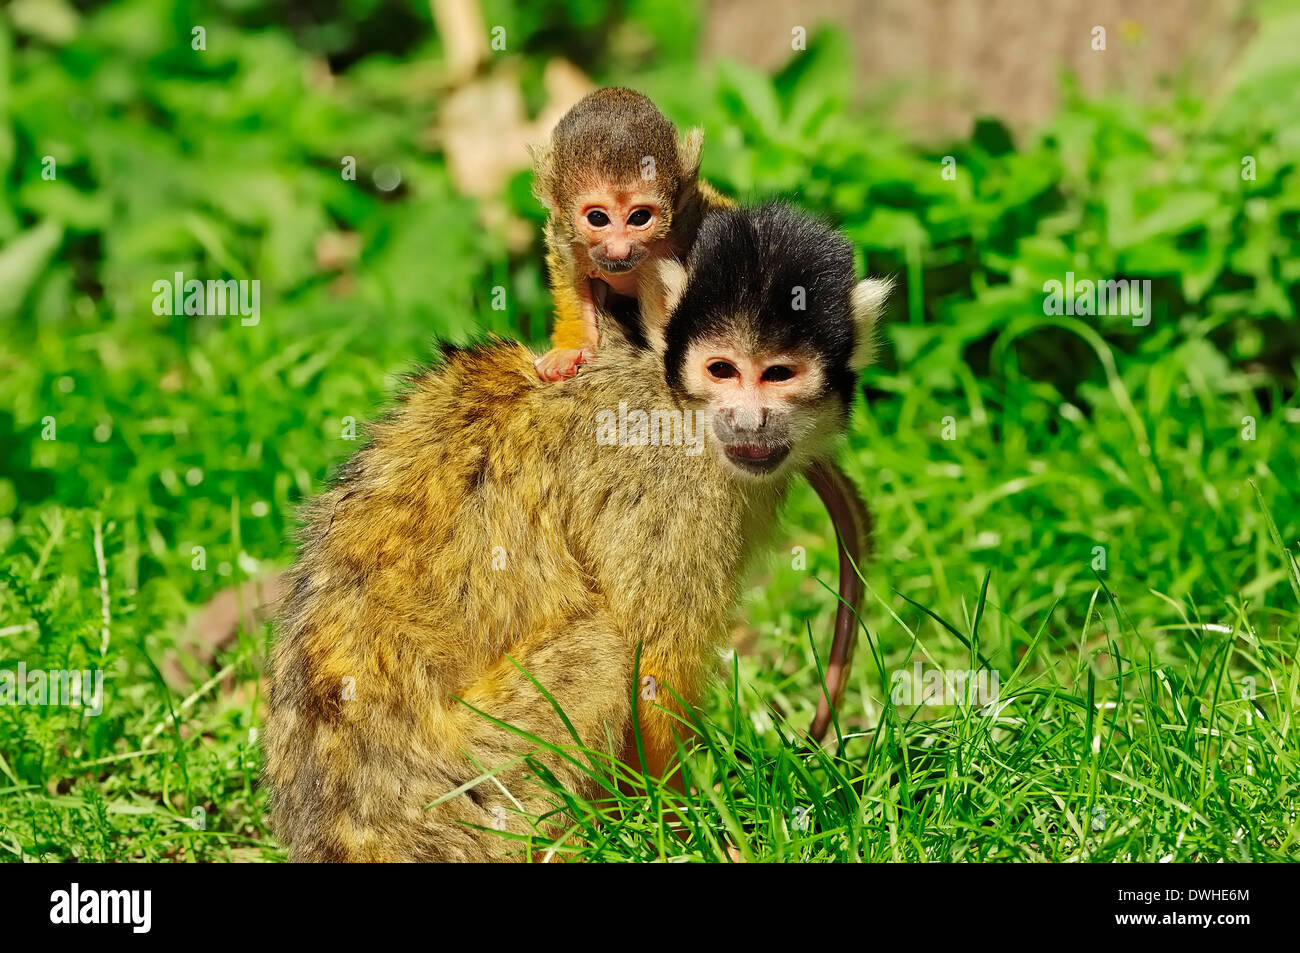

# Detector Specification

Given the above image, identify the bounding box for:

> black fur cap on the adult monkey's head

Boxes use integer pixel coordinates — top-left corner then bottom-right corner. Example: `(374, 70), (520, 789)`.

(664, 202), (857, 407)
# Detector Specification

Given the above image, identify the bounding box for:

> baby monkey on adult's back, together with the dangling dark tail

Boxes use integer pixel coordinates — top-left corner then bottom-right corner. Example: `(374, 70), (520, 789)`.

(533, 87), (871, 741)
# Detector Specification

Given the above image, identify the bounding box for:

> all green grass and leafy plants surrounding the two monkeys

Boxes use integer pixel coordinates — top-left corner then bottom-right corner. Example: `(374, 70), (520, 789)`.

(0, 0), (1300, 861)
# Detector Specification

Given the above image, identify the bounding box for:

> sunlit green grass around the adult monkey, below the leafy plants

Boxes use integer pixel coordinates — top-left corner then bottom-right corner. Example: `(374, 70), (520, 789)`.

(0, 302), (1300, 861)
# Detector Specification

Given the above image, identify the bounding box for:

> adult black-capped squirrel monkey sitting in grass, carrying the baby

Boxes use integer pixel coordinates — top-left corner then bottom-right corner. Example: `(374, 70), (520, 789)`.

(264, 205), (885, 861)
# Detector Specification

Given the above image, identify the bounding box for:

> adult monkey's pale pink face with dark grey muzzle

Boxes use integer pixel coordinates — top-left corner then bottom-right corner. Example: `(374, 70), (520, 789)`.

(683, 342), (833, 477)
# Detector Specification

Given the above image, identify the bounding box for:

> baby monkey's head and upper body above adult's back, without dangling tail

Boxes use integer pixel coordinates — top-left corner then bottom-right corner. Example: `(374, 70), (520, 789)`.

(533, 87), (733, 381)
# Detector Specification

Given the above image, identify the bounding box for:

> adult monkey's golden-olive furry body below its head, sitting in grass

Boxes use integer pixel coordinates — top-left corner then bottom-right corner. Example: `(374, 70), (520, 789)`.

(265, 335), (784, 861)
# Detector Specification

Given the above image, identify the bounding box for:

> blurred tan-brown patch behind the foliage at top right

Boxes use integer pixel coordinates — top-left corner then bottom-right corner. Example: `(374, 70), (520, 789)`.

(703, 0), (1258, 137)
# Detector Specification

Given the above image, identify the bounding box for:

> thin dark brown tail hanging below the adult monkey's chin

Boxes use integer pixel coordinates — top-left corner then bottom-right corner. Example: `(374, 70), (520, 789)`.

(807, 460), (871, 742)
